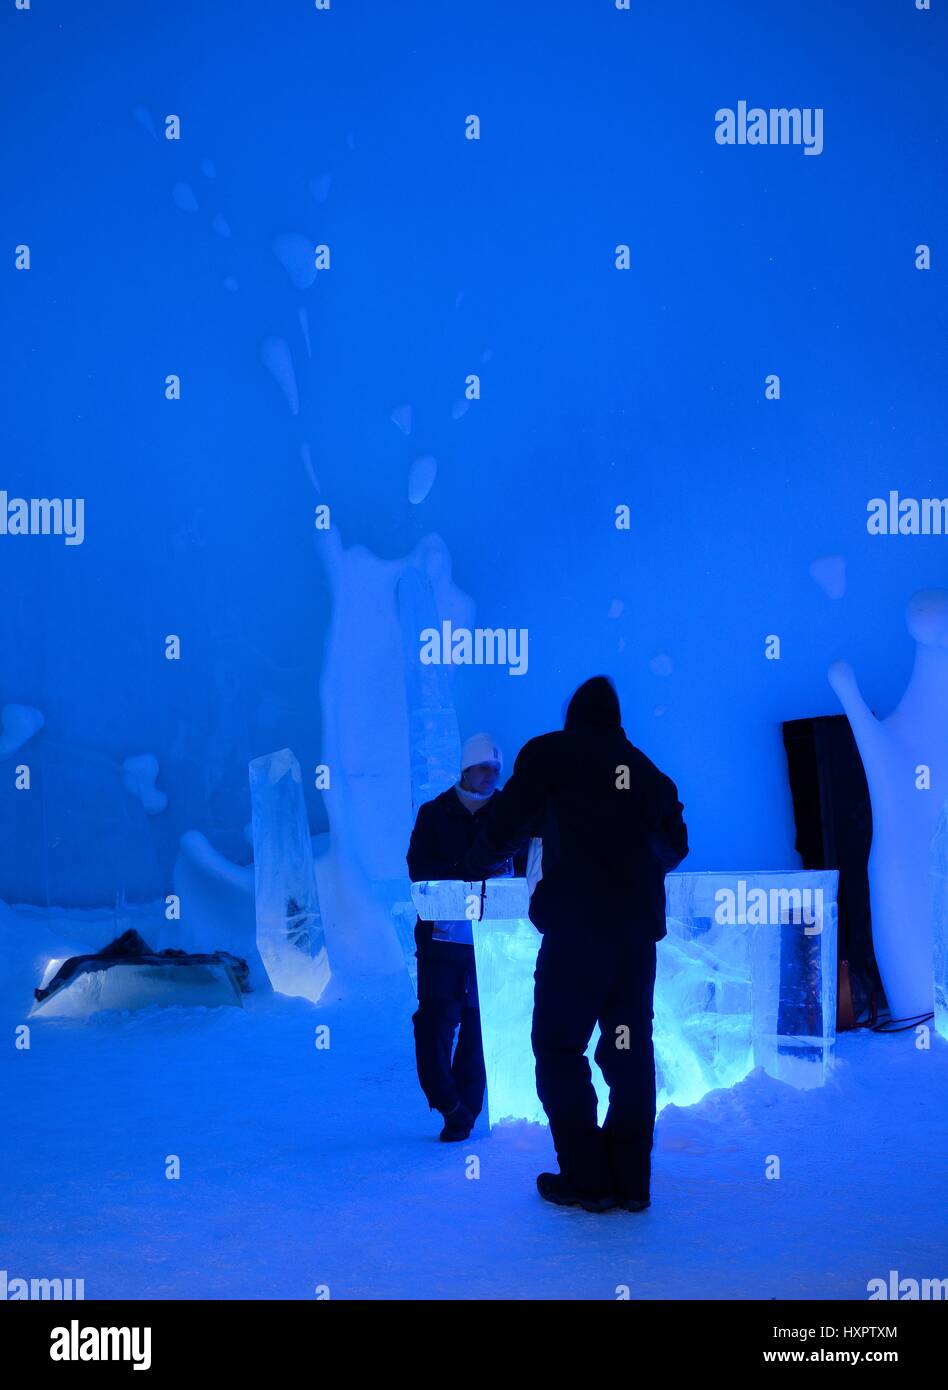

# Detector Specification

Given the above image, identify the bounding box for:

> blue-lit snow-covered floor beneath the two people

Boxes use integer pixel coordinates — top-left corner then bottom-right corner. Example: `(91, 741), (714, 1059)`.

(0, 913), (948, 1300)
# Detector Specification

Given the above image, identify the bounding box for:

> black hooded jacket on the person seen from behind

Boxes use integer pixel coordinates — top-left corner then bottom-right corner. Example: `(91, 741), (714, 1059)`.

(455, 676), (688, 941)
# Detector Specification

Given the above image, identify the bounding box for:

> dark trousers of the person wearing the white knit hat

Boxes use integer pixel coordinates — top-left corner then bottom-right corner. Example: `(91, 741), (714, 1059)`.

(411, 933), (487, 1116)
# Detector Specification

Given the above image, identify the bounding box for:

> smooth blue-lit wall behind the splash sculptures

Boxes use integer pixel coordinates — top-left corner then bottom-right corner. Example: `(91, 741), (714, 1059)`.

(0, 0), (948, 902)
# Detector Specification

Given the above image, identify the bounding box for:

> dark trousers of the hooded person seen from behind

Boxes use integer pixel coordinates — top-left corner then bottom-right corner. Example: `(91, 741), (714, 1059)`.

(532, 931), (655, 1198)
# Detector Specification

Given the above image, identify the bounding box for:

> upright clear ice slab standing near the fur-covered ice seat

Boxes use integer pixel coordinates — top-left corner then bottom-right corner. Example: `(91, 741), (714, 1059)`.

(250, 748), (329, 1002)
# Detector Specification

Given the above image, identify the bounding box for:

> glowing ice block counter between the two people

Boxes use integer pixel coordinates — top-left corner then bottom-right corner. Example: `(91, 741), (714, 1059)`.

(411, 872), (837, 1125)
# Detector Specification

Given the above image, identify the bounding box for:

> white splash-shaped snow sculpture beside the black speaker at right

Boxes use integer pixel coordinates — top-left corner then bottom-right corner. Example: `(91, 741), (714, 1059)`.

(828, 589), (948, 1019)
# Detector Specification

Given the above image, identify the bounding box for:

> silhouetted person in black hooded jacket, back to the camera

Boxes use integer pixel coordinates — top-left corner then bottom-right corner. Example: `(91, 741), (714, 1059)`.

(453, 676), (688, 1211)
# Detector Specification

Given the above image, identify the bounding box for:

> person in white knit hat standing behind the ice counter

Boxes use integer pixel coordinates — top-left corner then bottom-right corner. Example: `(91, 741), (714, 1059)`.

(407, 733), (524, 1143)
